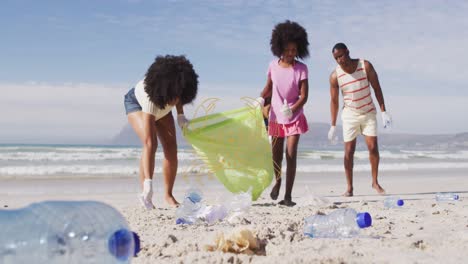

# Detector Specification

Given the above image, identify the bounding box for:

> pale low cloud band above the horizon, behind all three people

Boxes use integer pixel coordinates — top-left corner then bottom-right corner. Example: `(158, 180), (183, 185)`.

(0, 80), (468, 143)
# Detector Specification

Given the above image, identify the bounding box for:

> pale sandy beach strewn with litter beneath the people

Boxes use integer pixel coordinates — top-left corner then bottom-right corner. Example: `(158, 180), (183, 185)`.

(0, 170), (468, 263)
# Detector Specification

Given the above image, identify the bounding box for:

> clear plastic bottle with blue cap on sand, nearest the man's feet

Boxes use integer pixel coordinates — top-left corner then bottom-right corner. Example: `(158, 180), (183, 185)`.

(304, 208), (372, 238)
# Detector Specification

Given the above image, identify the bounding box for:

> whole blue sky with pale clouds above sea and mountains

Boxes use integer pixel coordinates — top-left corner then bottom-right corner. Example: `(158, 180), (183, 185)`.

(0, 0), (468, 143)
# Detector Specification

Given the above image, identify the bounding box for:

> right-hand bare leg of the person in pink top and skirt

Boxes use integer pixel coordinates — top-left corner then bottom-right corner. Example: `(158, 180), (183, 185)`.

(280, 135), (300, 206)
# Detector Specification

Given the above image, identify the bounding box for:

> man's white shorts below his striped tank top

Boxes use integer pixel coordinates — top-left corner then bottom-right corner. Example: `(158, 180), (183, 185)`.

(341, 107), (377, 142)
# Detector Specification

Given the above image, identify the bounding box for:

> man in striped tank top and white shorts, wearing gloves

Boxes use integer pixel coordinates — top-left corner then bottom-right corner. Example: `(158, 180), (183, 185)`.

(328, 43), (391, 196)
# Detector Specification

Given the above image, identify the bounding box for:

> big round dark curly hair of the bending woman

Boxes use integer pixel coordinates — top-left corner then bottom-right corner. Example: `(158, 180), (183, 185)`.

(145, 55), (198, 108)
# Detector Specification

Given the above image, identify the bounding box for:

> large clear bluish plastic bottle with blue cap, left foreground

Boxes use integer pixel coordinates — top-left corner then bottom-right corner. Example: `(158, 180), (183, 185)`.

(0, 201), (140, 264)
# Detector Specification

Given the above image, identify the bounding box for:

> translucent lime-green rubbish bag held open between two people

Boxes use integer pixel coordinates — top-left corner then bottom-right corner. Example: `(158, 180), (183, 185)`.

(184, 98), (273, 201)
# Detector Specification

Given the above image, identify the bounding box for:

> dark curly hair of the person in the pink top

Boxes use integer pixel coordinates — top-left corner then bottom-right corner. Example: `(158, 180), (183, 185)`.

(270, 20), (309, 59)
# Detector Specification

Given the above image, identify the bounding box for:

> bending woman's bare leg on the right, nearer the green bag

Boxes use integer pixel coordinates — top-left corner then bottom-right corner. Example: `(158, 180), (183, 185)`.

(156, 113), (179, 206)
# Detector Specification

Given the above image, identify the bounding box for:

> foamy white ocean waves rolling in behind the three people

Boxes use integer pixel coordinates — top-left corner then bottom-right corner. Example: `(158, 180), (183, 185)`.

(0, 145), (468, 179)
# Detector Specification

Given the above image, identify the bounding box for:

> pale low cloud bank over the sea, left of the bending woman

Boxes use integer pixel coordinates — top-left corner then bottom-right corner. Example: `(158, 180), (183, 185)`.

(0, 82), (126, 143)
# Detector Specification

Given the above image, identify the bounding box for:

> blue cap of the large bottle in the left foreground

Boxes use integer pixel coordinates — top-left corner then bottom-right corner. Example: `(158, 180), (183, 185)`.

(107, 229), (140, 261)
